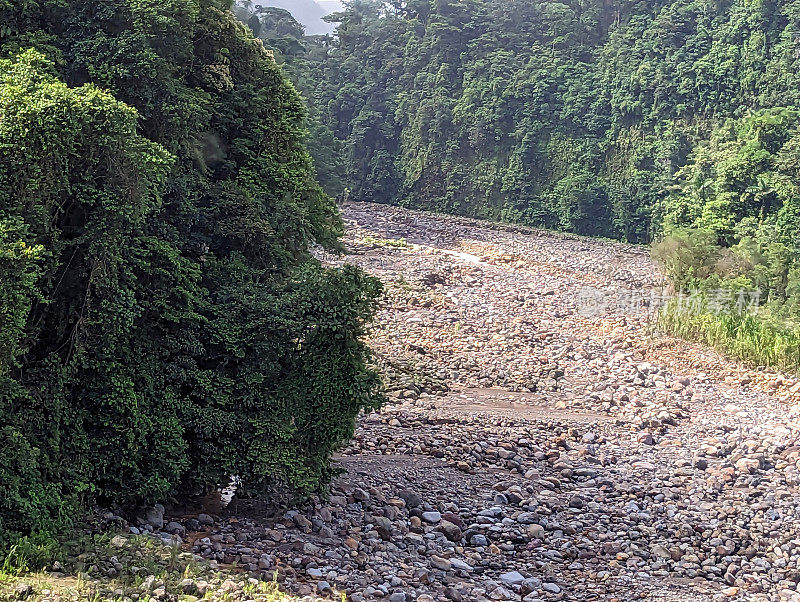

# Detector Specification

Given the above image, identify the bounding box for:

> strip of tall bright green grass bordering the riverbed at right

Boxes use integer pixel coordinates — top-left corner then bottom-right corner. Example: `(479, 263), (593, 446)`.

(659, 302), (800, 373)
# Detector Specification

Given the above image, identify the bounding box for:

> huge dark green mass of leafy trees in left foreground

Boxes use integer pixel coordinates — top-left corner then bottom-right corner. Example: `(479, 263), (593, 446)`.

(0, 0), (380, 546)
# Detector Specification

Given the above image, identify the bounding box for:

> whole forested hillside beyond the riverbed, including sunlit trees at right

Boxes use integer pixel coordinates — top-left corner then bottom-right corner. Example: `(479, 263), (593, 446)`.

(234, 0), (800, 368)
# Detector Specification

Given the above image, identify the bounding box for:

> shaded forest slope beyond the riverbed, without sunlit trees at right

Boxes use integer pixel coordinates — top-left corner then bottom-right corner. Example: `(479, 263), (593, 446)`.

(282, 0), (800, 242)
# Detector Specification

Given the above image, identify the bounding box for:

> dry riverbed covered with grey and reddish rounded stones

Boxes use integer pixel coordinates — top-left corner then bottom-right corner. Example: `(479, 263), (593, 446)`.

(9, 204), (800, 602)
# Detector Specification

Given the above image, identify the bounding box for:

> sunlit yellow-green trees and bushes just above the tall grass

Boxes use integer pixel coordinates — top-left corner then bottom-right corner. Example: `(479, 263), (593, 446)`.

(655, 108), (800, 301)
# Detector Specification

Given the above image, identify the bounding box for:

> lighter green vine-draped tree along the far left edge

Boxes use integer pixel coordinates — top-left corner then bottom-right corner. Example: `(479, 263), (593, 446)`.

(0, 51), (177, 532)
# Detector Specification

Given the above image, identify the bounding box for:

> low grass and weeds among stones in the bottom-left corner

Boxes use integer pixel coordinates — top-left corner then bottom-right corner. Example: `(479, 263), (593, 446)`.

(0, 534), (336, 602)
